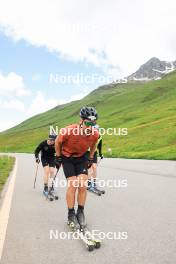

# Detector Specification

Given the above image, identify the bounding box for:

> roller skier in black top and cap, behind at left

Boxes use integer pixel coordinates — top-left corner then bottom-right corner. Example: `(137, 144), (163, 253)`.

(35, 135), (56, 192)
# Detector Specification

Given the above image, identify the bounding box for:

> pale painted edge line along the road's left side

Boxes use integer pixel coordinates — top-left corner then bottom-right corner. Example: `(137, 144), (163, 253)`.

(0, 158), (18, 260)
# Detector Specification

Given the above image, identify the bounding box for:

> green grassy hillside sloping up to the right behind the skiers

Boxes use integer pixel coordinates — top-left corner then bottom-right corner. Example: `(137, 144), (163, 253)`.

(0, 72), (176, 159)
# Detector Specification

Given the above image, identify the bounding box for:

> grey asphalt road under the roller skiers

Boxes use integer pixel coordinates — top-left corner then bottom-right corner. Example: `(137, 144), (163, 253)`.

(0, 154), (176, 264)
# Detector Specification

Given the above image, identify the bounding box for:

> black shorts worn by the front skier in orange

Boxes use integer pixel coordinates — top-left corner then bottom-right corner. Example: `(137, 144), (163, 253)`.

(62, 155), (88, 178)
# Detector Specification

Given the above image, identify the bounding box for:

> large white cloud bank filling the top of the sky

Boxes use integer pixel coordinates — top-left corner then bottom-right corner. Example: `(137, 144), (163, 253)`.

(0, 0), (176, 75)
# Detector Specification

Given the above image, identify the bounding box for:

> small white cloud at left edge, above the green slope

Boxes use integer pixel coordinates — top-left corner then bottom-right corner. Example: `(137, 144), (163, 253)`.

(0, 72), (30, 97)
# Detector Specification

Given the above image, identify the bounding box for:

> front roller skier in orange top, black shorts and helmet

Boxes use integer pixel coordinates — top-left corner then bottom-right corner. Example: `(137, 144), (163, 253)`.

(55, 107), (99, 227)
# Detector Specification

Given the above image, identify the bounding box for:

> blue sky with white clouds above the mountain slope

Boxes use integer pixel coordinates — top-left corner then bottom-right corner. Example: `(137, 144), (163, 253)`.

(0, 0), (176, 131)
